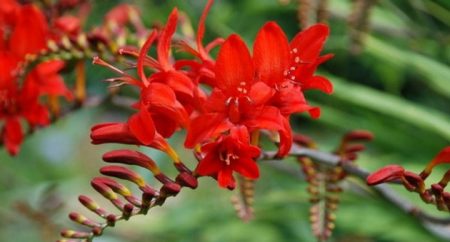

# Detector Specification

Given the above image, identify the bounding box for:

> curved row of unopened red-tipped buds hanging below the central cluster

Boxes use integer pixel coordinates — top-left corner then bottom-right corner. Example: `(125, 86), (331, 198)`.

(58, 149), (197, 242)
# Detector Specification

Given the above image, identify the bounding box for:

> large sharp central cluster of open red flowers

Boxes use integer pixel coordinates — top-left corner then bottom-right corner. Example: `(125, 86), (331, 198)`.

(91, 1), (332, 189)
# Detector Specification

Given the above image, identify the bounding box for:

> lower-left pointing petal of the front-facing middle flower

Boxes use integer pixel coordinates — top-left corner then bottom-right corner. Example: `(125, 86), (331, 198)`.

(184, 113), (232, 148)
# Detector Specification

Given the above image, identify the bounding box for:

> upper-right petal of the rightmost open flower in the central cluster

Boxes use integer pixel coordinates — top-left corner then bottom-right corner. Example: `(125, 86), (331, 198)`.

(291, 24), (330, 62)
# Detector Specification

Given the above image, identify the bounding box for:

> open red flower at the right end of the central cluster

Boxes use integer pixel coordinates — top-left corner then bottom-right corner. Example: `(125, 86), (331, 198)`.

(253, 22), (332, 117)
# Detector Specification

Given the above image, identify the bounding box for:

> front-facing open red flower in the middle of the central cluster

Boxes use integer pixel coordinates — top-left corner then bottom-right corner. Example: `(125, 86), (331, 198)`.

(185, 35), (284, 148)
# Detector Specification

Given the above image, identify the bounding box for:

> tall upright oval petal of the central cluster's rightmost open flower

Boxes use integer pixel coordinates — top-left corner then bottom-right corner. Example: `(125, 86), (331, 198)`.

(253, 22), (290, 86)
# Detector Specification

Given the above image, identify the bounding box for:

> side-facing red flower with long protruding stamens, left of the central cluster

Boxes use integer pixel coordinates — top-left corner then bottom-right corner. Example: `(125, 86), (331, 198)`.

(94, 9), (194, 145)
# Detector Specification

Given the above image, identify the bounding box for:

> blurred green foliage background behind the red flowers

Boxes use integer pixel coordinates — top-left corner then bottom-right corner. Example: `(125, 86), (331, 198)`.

(0, 0), (450, 242)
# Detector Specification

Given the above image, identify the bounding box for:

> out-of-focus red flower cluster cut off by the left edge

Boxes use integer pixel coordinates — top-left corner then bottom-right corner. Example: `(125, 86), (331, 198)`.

(0, 0), (71, 155)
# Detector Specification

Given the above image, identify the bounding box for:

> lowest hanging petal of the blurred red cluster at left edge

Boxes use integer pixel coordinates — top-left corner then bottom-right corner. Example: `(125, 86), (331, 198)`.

(3, 118), (23, 155)
